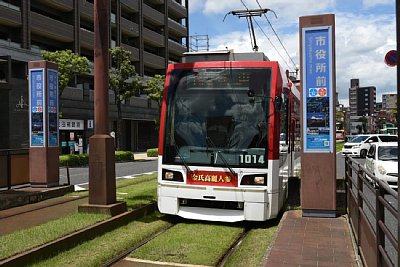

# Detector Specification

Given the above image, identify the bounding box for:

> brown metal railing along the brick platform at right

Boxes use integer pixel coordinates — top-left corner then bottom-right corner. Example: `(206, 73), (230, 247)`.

(345, 156), (398, 266)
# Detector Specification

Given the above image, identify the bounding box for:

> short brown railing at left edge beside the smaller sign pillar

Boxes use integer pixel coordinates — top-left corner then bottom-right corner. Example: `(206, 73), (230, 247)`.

(0, 149), (29, 190)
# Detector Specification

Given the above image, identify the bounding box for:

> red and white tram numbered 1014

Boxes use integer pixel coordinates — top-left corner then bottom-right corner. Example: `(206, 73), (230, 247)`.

(157, 52), (300, 222)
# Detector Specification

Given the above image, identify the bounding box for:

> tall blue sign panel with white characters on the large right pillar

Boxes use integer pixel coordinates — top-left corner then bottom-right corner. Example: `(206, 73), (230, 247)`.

(302, 26), (335, 153)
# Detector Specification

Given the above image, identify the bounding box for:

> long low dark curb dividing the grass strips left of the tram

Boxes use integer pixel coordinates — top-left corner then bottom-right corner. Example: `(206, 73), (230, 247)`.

(0, 202), (157, 266)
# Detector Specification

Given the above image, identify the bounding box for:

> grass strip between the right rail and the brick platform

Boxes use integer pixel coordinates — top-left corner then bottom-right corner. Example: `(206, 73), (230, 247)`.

(224, 219), (279, 267)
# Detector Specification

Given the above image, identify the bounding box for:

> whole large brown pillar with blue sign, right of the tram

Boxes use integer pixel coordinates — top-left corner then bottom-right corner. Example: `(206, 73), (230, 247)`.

(300, 14), (336, 217)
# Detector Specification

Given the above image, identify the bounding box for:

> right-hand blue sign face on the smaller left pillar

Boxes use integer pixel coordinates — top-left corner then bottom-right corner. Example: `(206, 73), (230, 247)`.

(47, 69), (58, 147)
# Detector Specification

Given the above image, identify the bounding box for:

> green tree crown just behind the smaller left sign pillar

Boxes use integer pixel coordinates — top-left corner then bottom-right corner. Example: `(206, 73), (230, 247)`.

(41, 50), (90, 96)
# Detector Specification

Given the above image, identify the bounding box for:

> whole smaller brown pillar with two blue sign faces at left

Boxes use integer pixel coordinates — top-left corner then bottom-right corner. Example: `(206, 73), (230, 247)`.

(28, 60), (60, 187)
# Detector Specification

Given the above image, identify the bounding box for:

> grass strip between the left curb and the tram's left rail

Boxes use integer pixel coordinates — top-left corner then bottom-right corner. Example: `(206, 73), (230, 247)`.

(27, 214), (172, 266)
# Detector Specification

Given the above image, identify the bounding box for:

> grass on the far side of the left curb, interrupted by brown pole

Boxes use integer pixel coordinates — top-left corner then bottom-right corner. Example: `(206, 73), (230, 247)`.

(0, 174), (157, 259)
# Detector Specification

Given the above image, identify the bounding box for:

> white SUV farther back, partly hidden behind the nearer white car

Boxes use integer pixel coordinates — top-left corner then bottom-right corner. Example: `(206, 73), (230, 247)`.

(342, 134), (397, 158)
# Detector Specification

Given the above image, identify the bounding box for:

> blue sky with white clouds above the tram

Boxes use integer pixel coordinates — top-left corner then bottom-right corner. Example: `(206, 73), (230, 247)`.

(189, 0), (397, 106)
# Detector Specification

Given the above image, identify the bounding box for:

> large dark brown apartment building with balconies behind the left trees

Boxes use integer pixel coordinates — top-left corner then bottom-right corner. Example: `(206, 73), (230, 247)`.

(0, 0), (189, 153)
